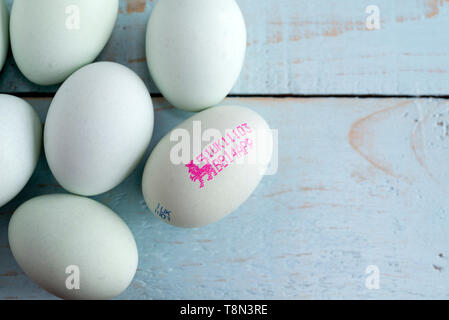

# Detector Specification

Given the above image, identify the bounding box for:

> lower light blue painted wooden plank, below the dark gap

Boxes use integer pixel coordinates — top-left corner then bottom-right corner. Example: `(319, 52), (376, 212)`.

(0, 98), (449, 299)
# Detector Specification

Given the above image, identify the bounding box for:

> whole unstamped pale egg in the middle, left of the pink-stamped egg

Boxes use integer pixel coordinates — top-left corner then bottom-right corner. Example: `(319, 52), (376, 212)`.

(44, 62), (154, 196)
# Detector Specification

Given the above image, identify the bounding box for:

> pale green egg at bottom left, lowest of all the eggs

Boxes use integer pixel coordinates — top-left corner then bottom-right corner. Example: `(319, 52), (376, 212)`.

(8, 194), (138, 299)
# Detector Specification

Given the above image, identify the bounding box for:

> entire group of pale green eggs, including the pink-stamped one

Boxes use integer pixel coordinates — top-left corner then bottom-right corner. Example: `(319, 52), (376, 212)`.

(0, 0), (273, 299)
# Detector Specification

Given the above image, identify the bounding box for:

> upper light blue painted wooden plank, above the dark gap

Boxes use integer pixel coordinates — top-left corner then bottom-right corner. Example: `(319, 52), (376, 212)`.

(0, 0), (449, 95)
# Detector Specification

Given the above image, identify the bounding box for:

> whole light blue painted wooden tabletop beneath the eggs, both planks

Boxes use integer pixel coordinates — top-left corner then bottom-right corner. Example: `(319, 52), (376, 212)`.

(0, 0), (449, 299)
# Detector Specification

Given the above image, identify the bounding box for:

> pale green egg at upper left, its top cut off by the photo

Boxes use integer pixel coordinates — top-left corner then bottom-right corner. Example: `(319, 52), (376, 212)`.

(10, 0), (119, 85)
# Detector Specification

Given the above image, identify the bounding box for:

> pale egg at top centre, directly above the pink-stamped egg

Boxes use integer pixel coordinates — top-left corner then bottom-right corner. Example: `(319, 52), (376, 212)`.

(146, 0), (246, 111)
